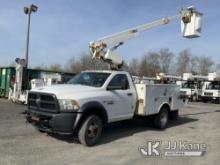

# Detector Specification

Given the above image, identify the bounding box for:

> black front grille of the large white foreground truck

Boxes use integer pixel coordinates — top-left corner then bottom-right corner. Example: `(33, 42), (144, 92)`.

(28, 92), (59, 112)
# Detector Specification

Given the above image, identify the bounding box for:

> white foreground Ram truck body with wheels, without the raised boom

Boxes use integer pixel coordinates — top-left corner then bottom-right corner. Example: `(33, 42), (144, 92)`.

(26, 70), (184, 146)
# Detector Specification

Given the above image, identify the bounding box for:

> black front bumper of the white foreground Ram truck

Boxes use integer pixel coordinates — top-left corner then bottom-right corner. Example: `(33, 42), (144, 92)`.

(26, 110), (81, 135)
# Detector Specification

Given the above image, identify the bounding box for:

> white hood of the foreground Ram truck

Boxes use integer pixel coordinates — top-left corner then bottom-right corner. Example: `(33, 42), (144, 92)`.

(31, 84), (101, 99)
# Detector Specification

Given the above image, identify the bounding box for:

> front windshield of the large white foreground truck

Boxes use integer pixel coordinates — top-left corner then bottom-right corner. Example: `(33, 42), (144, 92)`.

(67, 72), (110, 87)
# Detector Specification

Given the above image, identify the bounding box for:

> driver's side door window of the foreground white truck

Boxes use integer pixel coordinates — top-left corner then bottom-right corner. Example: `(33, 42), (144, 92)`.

(109, 74), (130, 90)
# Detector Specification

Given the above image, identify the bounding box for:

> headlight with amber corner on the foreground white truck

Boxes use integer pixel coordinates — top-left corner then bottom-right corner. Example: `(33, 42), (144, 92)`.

(59, 99), (79, 111)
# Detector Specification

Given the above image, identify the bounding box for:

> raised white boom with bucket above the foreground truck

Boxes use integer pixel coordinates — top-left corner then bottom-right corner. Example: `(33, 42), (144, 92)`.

(89, 7), (202, 69)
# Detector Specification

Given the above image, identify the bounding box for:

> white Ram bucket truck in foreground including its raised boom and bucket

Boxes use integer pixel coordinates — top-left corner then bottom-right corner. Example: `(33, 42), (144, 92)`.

(26, 7), (202, 146)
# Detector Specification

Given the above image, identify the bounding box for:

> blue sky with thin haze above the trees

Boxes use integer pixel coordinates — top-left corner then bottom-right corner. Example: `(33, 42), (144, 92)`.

(0, 0), (220, 67)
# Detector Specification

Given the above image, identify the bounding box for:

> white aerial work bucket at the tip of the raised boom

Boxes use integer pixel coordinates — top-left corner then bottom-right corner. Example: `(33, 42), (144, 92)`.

(181, 7), (203, 38)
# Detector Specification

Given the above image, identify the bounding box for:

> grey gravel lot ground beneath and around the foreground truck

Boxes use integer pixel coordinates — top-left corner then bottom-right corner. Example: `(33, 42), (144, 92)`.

(0, 100), (220, 165)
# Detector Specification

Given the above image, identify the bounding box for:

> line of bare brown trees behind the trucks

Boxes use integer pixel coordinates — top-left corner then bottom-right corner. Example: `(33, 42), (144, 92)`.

(36, 48), (220, 77)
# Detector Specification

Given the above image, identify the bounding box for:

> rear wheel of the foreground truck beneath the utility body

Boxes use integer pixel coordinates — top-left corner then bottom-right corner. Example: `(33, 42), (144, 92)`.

(153, 107), (169, 129)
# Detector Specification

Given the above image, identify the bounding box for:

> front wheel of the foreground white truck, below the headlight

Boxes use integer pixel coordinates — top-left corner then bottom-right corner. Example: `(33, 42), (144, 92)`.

(78, 115), (102, 146)
